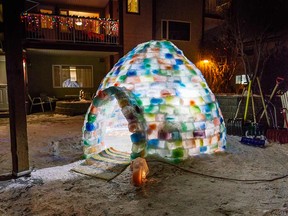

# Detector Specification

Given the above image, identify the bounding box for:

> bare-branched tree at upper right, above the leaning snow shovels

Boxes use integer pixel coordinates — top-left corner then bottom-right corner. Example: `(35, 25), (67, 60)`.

(226, 0), (288, 81)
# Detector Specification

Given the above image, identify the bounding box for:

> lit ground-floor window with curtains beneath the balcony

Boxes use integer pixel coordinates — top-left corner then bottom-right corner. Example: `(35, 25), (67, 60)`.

(52, 65), (93, 88)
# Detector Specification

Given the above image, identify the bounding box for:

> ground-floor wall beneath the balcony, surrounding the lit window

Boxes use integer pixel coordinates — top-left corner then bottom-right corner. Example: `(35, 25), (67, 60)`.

(27, 51), (109, 99)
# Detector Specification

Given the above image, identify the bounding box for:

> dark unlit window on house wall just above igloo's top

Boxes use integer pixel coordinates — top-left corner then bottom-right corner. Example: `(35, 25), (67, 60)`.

(162, 20), (191, 41)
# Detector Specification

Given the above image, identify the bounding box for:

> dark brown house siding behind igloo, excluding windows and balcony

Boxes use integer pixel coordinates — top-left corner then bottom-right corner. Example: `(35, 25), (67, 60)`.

(26, 0), (203, 99)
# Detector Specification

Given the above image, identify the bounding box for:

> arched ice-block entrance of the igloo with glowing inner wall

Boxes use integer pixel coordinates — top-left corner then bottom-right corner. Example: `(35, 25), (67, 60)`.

(83, 86), (147, 159)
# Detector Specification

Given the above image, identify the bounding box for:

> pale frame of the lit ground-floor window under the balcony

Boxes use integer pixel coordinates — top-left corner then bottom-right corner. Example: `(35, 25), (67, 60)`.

(52, 64), (94, 89)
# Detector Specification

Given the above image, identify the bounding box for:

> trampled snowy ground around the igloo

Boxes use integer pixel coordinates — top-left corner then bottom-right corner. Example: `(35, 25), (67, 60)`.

(0, 113), (288, 216)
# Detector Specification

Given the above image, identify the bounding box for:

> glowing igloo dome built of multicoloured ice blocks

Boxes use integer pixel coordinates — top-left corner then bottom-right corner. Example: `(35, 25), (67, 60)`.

(82, 41), (226, 160)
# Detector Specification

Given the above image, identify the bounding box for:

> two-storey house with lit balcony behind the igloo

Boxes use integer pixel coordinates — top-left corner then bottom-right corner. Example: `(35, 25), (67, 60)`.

(0, 0), (203, 109)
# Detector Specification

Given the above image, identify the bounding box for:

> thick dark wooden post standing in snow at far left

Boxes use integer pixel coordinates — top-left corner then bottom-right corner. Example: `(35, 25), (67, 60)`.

(3, 0), (31, 177)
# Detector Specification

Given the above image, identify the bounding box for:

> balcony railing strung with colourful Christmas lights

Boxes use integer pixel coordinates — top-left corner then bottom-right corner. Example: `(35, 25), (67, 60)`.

(21, 13), (119, 45)
